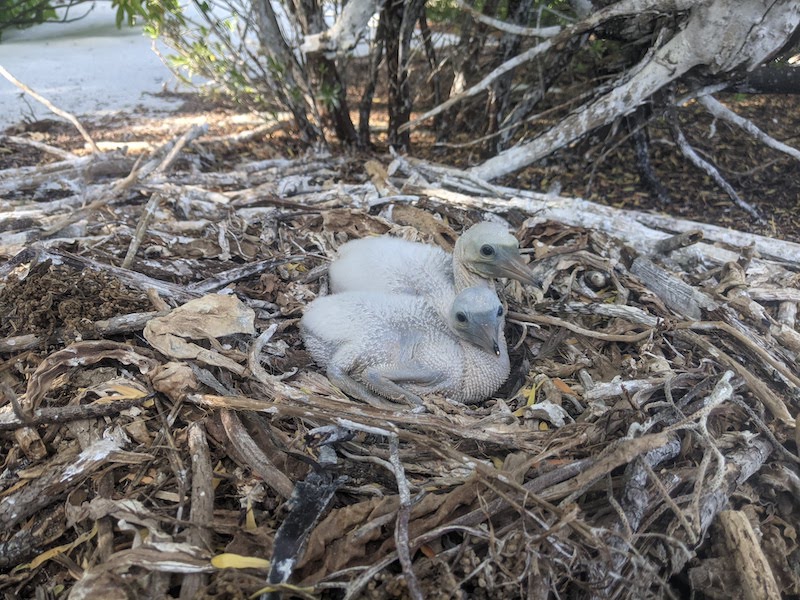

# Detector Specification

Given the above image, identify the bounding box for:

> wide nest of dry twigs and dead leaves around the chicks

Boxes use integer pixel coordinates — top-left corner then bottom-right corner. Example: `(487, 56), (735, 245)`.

(0, 124), (800, 598)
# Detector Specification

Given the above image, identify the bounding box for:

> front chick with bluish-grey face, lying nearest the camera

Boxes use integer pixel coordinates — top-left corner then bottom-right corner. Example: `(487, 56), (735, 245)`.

(300, 287), (509, 404)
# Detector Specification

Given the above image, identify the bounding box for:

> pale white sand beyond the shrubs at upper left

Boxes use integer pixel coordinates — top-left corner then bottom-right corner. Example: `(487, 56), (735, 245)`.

(0, 2), (191, 130)
